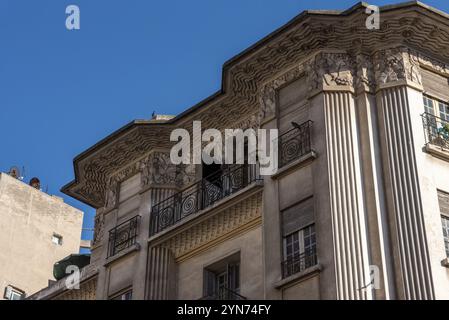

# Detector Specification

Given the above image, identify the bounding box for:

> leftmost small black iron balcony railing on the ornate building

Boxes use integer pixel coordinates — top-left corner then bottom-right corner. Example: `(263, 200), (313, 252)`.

(108, 216), (140, 258)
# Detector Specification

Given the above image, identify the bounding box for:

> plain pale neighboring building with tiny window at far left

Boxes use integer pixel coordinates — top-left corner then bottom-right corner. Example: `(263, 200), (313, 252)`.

(0, 173), (83, 300)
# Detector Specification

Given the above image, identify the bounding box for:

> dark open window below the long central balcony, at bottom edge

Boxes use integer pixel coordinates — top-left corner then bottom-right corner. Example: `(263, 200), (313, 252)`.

(203, 253), (246, 300)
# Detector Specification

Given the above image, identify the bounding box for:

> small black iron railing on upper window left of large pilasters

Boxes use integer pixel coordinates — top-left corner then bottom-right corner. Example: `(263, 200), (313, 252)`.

(278, 120), (313, 167)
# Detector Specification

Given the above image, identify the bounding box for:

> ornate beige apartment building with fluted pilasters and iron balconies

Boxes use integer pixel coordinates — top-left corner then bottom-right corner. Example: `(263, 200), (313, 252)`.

(30, 2), (449, 300)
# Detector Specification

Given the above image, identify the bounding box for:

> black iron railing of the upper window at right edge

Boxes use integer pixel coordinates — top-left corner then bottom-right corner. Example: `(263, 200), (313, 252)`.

(422, 113), (449, 150)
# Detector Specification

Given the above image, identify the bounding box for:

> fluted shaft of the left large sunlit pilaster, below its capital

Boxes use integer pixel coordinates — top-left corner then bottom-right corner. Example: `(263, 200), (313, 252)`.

(324, 92), (372, 299)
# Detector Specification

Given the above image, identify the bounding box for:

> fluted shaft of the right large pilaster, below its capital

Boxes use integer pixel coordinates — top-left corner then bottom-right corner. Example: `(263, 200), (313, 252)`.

(379, 86), (434, 299)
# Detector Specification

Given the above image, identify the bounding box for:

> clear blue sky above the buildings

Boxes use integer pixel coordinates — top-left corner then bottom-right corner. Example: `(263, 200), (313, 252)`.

(0, 0), (449, 242)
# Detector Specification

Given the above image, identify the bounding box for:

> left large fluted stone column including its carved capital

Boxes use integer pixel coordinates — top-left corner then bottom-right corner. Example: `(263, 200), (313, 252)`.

(308, 53), (372, 299)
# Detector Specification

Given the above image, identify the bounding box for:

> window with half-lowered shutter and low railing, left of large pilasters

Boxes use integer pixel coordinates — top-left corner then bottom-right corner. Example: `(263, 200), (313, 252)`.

(282, 197), (317, 278)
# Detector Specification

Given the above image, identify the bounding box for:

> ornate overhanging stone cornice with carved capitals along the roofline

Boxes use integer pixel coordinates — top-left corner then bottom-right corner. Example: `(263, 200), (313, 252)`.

(63, 3), (449, 208)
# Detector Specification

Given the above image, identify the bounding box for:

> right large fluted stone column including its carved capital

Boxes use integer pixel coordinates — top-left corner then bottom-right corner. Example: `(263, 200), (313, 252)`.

(374, 47), (434, 299)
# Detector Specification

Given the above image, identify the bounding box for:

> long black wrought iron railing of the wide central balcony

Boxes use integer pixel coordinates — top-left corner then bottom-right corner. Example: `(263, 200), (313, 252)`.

(150, 164), (260, 236)
